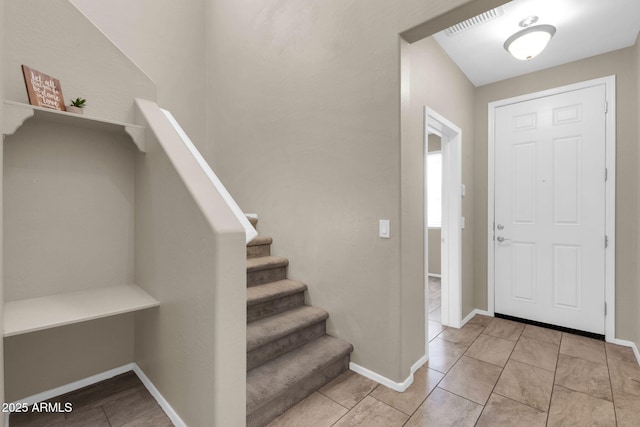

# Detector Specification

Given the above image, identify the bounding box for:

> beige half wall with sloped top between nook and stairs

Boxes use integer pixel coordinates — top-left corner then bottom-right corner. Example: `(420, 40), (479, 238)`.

(135, 107), (246, 427)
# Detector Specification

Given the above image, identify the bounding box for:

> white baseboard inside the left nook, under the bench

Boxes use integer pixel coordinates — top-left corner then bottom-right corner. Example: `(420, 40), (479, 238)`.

(4, 363), (187, 427)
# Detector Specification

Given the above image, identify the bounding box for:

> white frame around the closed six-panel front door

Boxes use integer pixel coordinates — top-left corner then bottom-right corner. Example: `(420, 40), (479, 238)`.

(487, 76), (616, 342)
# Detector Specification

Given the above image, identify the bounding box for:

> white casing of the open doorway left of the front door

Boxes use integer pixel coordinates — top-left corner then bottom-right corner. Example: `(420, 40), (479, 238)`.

(423, 106), (462, 332)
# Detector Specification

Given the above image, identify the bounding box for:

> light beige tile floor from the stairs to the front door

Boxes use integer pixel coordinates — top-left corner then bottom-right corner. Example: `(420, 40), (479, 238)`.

(269, 281), (640, 427)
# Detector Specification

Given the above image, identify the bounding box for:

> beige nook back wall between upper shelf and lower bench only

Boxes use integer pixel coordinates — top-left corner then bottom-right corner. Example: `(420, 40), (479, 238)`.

(4, 122), (136, 301)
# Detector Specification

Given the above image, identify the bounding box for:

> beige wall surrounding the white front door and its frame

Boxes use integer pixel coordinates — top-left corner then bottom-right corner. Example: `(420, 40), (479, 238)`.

(475, 48), (638, 340)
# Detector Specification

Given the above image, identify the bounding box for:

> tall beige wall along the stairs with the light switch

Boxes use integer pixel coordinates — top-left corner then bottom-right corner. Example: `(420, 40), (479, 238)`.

(207, 0), (484, 381)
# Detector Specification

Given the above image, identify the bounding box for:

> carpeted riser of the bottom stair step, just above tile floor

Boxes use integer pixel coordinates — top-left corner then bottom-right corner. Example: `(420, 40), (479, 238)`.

(247, 354), (349, 427)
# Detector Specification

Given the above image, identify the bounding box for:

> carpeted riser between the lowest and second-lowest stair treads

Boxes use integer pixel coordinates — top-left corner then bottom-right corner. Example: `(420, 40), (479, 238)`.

(247, 320), (326, 371)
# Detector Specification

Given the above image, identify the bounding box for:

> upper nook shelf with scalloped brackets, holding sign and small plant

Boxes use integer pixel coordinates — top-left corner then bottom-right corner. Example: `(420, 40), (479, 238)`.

(2, 100), (146, 153)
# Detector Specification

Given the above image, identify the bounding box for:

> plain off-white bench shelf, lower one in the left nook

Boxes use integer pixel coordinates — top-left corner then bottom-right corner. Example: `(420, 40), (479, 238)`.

(4, 285), (160, 337)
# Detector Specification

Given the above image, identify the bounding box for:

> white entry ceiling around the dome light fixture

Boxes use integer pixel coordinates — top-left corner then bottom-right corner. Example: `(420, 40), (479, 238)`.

(434, 0), (640, 86)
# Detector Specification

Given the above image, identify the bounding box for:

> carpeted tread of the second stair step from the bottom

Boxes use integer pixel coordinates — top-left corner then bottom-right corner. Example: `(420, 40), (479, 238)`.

(247, 305), (329, 352)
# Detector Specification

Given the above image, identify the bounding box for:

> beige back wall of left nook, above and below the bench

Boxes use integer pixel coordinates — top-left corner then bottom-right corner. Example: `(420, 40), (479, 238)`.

(3, 123), (136, 401)
